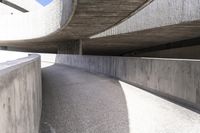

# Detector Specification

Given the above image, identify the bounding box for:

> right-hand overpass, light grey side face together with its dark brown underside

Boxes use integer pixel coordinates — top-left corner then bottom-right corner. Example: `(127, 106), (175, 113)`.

(83, 0), (200, 55)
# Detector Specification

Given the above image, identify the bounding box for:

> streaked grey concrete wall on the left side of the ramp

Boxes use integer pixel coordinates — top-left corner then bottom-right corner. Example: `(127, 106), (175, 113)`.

(0, 55), (42, 133)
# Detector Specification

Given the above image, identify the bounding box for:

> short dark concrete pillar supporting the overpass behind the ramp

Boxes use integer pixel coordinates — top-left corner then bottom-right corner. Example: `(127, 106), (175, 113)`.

(58, 40), (82, 55)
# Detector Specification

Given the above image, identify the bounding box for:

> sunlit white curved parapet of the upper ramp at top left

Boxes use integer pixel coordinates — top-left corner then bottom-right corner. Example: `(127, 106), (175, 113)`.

(0, 0), (74, 41)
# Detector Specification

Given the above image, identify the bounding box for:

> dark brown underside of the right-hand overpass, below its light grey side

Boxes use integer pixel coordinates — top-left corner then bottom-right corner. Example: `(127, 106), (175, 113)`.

(83, 21), (200, 55)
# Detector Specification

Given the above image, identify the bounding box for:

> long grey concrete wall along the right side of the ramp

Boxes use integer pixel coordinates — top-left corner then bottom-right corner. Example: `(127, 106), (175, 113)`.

(56, 55), (200, 109)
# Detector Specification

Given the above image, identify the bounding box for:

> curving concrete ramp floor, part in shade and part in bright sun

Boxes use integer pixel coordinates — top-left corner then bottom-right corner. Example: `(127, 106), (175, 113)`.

(40, 64), (200, 133)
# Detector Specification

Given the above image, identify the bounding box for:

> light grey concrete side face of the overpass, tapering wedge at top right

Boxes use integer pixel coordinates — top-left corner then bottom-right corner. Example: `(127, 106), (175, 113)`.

(91, 0), (200, 38)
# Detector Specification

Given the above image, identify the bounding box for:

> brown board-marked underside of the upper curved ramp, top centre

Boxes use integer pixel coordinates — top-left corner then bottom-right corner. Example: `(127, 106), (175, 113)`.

(39, 0), (149, 41)
